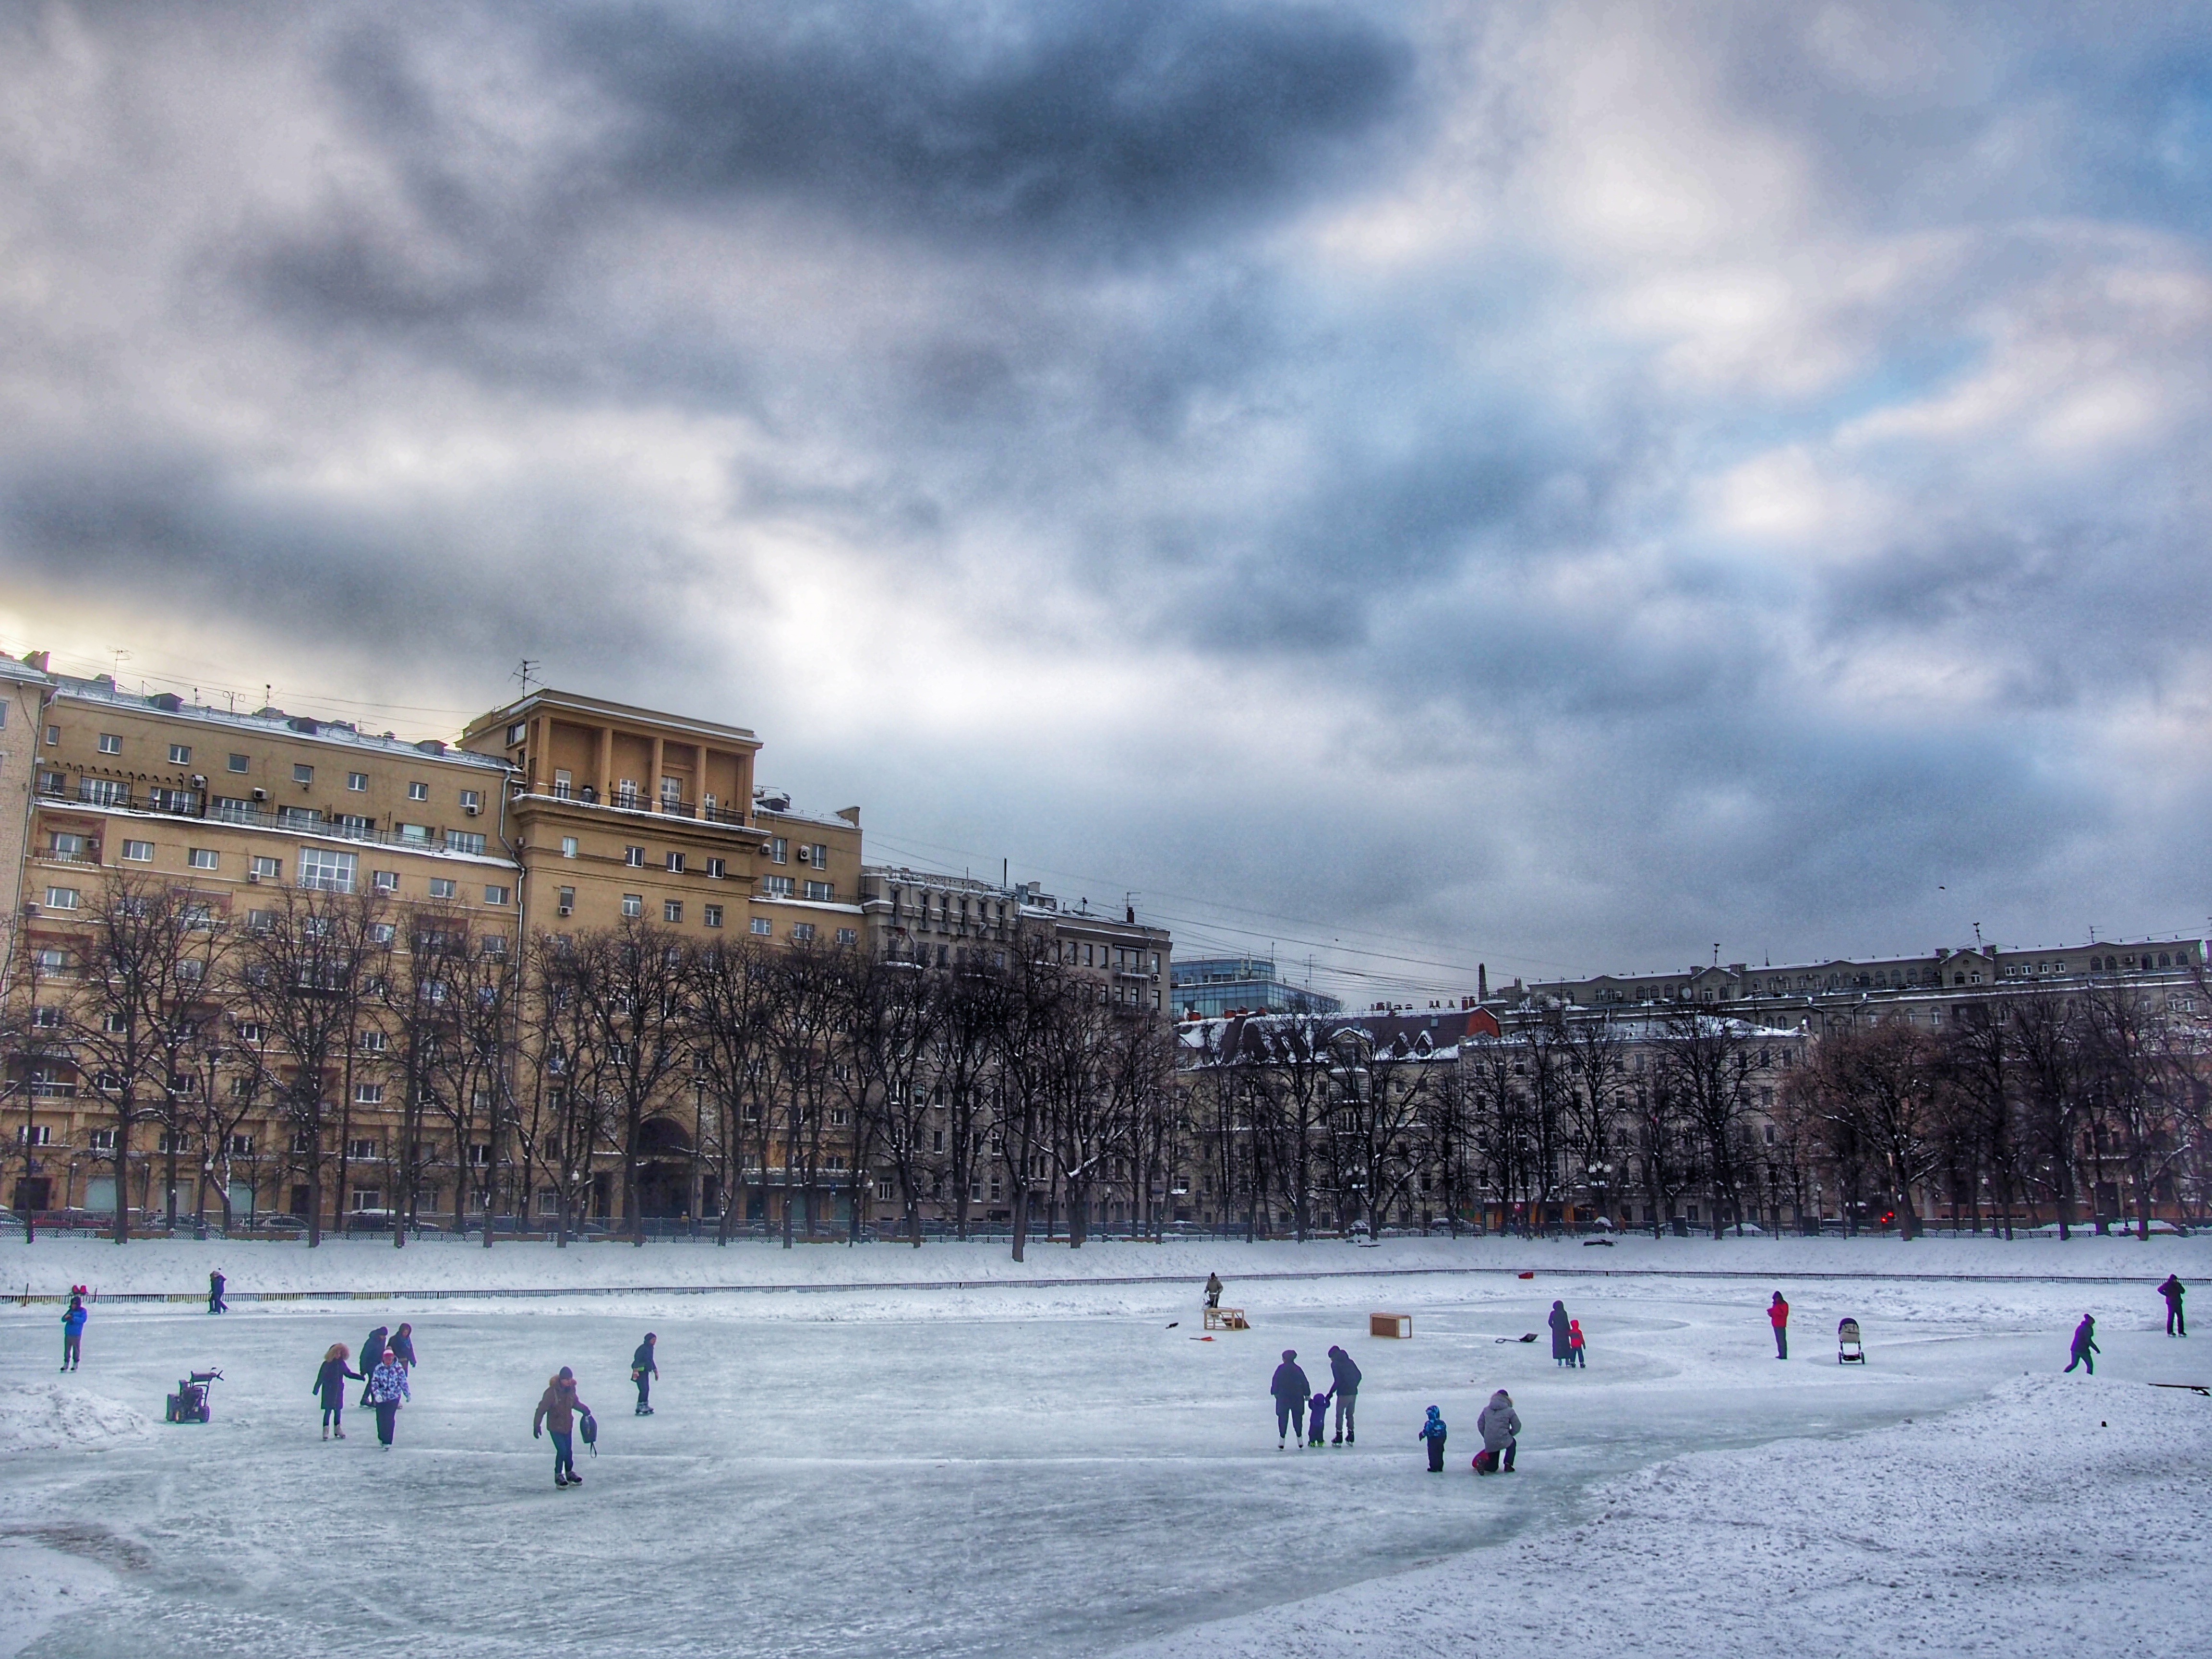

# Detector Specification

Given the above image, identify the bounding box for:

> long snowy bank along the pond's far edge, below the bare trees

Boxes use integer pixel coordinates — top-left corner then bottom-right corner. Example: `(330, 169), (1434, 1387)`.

(0, 1234), (2212, 1305)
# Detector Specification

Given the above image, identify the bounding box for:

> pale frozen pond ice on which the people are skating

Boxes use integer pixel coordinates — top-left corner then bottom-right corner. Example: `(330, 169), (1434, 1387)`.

(0, 1241), (2212, 1659)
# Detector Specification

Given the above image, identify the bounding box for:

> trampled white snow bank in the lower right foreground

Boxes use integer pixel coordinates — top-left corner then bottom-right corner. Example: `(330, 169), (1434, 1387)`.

(1126, 1376), (2212, 1659)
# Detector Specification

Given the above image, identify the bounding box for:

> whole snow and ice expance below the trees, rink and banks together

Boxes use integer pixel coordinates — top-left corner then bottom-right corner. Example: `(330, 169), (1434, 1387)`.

(0, 1238), (2212, 1659)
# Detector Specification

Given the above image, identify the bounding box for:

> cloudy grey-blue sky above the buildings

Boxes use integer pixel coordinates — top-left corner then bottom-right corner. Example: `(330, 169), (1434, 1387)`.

(0, 0), (2212, 1002)
